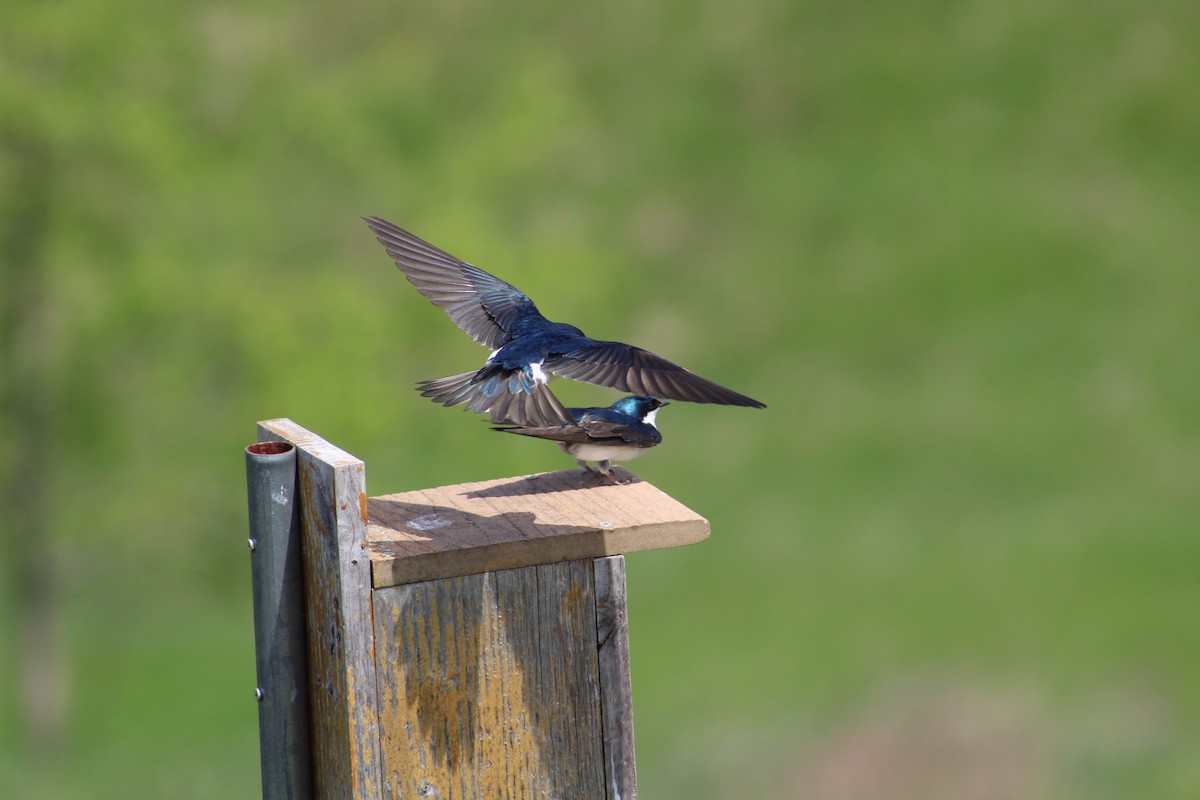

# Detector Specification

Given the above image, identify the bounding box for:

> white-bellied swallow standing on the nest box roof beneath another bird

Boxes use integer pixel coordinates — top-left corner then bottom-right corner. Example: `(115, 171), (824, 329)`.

(492, 396), (670, 482)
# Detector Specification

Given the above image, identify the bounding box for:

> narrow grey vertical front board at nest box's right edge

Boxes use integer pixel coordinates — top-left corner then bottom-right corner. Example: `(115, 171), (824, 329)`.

(593, 555), (637, 800)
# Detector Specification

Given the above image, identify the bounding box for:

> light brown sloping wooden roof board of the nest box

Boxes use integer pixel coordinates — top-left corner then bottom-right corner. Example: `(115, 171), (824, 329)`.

(367, 470), (708, 589)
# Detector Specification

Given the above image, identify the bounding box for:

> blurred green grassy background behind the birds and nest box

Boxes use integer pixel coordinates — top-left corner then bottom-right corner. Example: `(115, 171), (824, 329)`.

(0, 0), (1200, 800)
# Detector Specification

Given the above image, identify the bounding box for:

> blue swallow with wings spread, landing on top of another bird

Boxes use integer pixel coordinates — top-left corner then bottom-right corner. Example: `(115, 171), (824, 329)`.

(364, 217), (766, 426)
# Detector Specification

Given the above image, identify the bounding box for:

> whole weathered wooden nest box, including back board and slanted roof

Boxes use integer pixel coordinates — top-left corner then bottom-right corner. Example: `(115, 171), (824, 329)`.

(248, 420), (708, 800)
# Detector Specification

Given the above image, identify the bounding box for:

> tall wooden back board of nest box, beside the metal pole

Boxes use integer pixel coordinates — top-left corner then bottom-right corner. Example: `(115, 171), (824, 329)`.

(258, 420), (380, 800)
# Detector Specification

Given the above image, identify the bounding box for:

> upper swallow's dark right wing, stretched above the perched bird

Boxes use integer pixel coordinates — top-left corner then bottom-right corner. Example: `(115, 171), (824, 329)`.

(542, 342), (767, 408)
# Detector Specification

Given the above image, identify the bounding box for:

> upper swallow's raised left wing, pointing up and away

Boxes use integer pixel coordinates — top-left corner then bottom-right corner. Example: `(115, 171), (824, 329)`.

(364, 217), (538, 350)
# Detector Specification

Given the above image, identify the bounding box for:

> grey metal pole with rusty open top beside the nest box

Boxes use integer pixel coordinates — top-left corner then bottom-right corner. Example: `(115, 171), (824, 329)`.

(246, 441), (312, 800)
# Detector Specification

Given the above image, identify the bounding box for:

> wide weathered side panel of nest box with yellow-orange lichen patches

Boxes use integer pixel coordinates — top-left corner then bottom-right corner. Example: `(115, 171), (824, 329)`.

(373, 560), (605, 800)
